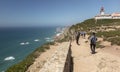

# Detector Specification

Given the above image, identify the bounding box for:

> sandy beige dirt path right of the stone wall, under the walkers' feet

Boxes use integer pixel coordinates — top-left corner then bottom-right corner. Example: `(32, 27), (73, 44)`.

(71, 38), (120, 72)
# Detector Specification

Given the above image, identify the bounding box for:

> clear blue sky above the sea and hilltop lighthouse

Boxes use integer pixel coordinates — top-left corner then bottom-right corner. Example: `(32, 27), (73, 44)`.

(0, 0), (120, 27)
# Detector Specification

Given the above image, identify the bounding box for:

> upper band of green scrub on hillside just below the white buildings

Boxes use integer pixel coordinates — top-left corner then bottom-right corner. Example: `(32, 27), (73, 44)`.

(70, 19), (120, 31)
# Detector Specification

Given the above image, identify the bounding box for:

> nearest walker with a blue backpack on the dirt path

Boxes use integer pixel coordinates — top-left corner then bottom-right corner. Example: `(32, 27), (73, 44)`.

(90, 32), (97, 54)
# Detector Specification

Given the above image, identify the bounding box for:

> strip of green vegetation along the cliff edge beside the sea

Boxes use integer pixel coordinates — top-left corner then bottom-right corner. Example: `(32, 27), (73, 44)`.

(6, 42), (54, 72)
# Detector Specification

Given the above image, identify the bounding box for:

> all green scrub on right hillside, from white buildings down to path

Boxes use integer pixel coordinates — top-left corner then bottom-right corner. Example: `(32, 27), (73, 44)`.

(69, 19), (120, 47)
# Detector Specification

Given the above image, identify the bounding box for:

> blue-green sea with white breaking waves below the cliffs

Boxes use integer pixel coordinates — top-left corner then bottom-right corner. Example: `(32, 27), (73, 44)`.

(0, 27), (57, 72)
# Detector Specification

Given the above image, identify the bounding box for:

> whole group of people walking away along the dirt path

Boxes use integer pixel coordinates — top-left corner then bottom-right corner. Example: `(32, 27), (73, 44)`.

(76, 31), (97, 54)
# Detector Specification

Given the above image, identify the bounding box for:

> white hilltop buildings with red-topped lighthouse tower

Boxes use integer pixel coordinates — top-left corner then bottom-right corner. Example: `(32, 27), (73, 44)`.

(94, 7), (120, 19)
